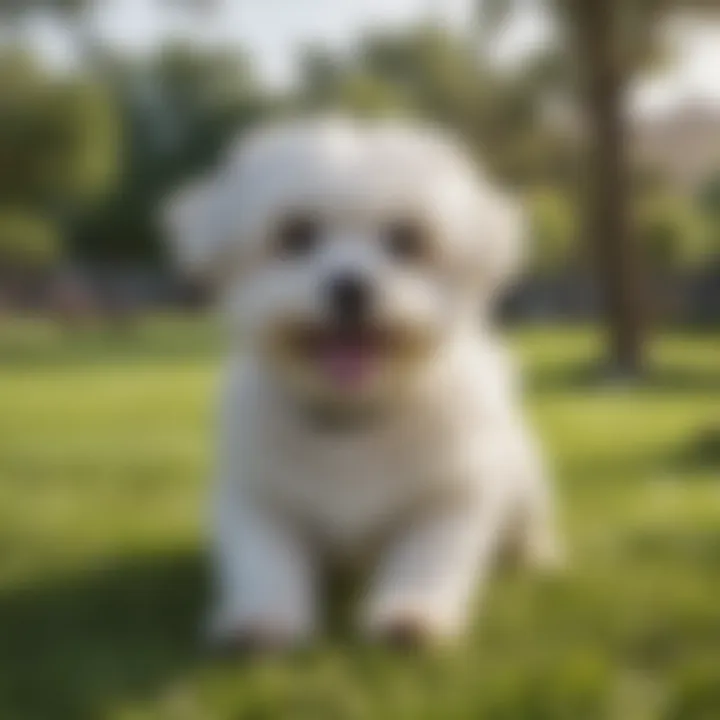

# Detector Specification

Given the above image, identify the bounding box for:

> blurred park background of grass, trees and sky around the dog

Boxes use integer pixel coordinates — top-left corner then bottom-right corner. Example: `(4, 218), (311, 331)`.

(0, 0), (720, 720)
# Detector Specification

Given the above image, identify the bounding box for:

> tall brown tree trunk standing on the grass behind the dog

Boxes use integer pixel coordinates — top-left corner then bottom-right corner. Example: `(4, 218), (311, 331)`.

(570, 0), (644, 378)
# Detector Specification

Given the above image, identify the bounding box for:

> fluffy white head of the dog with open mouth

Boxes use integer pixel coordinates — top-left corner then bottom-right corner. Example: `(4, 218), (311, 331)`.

(164, 119), (521, 416)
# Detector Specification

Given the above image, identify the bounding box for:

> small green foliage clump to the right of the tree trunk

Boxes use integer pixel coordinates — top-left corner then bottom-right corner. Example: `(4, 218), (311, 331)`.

(637, 193), (710, 270)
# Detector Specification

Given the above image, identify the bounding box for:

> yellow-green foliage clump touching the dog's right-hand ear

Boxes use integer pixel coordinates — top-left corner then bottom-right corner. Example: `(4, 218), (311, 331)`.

(528, 188), (578, 273)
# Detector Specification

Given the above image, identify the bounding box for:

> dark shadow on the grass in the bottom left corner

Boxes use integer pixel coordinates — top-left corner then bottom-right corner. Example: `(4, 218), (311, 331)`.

(0, 551), (206, 720)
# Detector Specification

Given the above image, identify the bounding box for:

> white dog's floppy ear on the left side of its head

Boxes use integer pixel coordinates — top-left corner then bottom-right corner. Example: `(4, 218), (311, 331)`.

(162, 177), (227, 283)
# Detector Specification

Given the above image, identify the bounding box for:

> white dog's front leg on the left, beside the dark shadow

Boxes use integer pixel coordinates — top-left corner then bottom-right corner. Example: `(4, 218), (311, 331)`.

(210, 480), (316, 651)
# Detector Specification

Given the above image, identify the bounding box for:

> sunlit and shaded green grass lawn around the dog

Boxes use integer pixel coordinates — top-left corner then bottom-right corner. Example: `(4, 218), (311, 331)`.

(0, 318), (720, 720)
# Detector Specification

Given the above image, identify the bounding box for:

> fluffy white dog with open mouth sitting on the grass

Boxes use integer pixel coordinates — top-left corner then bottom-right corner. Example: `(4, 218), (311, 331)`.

(165, 119), (557, 644)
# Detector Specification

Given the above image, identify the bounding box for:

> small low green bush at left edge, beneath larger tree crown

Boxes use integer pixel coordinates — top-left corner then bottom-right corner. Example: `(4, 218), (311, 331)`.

(0, 208), (60, 269)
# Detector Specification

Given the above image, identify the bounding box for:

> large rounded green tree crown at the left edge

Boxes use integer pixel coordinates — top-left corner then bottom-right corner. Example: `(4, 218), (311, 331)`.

(0, 49), (117, 262)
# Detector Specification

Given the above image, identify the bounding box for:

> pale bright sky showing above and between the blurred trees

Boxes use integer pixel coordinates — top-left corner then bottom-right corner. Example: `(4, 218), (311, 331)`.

(26, 0), (720, 114)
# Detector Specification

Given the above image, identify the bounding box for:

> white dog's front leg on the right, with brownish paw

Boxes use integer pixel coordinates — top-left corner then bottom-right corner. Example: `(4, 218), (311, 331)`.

(361, 492), (509, 644)
